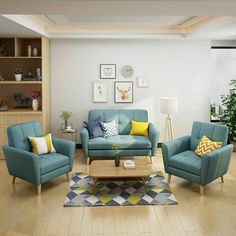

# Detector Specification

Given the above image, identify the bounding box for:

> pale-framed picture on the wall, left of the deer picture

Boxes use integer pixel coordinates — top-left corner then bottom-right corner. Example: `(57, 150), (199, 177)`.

(93, 81), (107, 102)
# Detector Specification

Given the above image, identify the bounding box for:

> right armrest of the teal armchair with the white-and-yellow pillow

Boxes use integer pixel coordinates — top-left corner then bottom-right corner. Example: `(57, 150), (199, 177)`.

(52, 137), (75, 170)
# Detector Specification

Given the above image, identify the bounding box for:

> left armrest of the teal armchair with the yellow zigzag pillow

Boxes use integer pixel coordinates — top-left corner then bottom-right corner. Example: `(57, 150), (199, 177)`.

(161, 136), (190, 173)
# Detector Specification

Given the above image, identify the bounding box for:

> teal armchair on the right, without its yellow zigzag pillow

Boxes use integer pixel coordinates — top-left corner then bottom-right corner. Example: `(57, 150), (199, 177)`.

(162, 121), (233, 194)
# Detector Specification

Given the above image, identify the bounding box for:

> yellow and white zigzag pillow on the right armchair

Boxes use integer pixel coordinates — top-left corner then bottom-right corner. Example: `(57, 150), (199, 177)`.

(195, 136), (223, 157)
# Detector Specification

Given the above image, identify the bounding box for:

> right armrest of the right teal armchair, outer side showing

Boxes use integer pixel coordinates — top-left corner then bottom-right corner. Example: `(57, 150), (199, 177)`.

(201, 144), (233, 186)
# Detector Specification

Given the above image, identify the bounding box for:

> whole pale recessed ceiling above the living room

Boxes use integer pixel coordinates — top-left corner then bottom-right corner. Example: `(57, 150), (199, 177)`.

(0, 0), (236, 39)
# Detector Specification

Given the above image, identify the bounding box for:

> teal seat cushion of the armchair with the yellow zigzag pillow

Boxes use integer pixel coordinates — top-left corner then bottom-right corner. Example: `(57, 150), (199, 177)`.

(169, 151), (201, 175)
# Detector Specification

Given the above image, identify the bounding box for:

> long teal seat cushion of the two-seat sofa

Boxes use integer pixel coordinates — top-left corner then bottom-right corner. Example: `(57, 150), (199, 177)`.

(88, 135), (152, 150)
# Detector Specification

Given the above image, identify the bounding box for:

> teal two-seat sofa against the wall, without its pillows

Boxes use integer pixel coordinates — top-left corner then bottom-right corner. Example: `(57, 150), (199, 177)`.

(80, 109), (159, 164)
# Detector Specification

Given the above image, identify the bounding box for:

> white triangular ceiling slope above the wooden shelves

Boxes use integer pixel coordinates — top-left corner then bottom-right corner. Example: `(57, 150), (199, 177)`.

(2, 14), (49, 37)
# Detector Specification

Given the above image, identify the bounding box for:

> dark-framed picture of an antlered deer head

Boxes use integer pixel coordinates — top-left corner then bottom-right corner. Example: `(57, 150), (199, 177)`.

(114, 81), (133, 103)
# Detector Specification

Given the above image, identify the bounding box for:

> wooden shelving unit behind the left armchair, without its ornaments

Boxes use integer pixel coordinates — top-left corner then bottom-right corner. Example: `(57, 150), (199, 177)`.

(0, 37), (50, 158)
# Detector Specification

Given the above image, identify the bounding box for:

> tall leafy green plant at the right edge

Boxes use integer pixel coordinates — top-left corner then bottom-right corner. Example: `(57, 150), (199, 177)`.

(221, 80), (236, 152)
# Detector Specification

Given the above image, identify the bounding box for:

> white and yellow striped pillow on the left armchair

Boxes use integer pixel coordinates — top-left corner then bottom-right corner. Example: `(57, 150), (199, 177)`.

(28, 134), (56, 155)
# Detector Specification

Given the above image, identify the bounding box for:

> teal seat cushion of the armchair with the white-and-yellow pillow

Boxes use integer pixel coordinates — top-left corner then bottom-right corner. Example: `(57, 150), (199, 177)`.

(40, 153), (70, 174)
